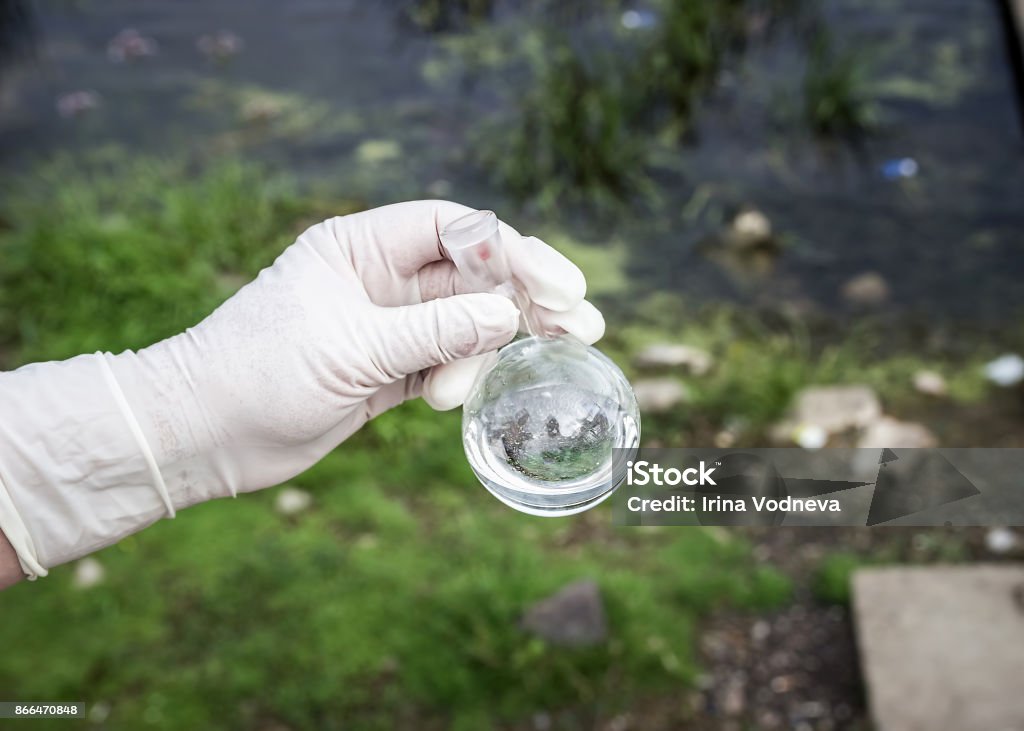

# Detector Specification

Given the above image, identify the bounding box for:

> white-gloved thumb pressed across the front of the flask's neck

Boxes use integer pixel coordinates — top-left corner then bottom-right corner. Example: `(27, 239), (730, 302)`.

(370, 294), (519, 381)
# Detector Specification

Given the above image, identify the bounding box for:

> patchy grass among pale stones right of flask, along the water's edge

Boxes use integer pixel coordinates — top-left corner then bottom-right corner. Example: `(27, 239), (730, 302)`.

(601, 293), (991, 445)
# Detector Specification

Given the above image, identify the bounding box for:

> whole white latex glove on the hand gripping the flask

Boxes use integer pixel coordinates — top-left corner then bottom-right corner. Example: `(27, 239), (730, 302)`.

(0, 201), (604, 575)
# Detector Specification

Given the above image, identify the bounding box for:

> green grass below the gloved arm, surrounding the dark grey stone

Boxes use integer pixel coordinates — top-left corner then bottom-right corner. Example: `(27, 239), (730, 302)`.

(0, 423), (787, 729)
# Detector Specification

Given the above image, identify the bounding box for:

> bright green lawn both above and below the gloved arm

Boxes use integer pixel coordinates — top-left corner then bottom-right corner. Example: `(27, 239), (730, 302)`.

(0, 153), (788, 730)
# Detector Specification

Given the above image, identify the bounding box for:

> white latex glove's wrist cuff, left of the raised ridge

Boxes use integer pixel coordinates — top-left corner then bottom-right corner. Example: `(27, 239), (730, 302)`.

(0, 353), (169, 575)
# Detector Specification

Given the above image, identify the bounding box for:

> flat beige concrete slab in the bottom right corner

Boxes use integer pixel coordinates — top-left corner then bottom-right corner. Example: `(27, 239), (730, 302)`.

(851, 564), (1024, 731)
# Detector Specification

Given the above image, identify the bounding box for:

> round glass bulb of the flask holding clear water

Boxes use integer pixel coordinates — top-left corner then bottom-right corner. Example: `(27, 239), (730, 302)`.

(462, 336), (640, 515)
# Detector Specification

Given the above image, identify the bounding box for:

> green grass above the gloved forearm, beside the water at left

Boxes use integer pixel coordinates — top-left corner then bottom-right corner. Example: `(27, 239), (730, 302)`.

(0, 151), (297, 362)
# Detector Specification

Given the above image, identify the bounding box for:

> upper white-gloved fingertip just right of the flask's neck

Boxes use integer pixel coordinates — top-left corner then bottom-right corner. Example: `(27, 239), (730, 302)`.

(502, 236), (587, 312)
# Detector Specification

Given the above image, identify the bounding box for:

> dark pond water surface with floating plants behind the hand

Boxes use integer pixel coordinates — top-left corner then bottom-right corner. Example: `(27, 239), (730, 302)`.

(0, 0), (1024, 325)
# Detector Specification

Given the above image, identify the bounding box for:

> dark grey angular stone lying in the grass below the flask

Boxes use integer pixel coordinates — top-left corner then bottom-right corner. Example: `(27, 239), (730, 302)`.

(520, 579), (608, 647)
